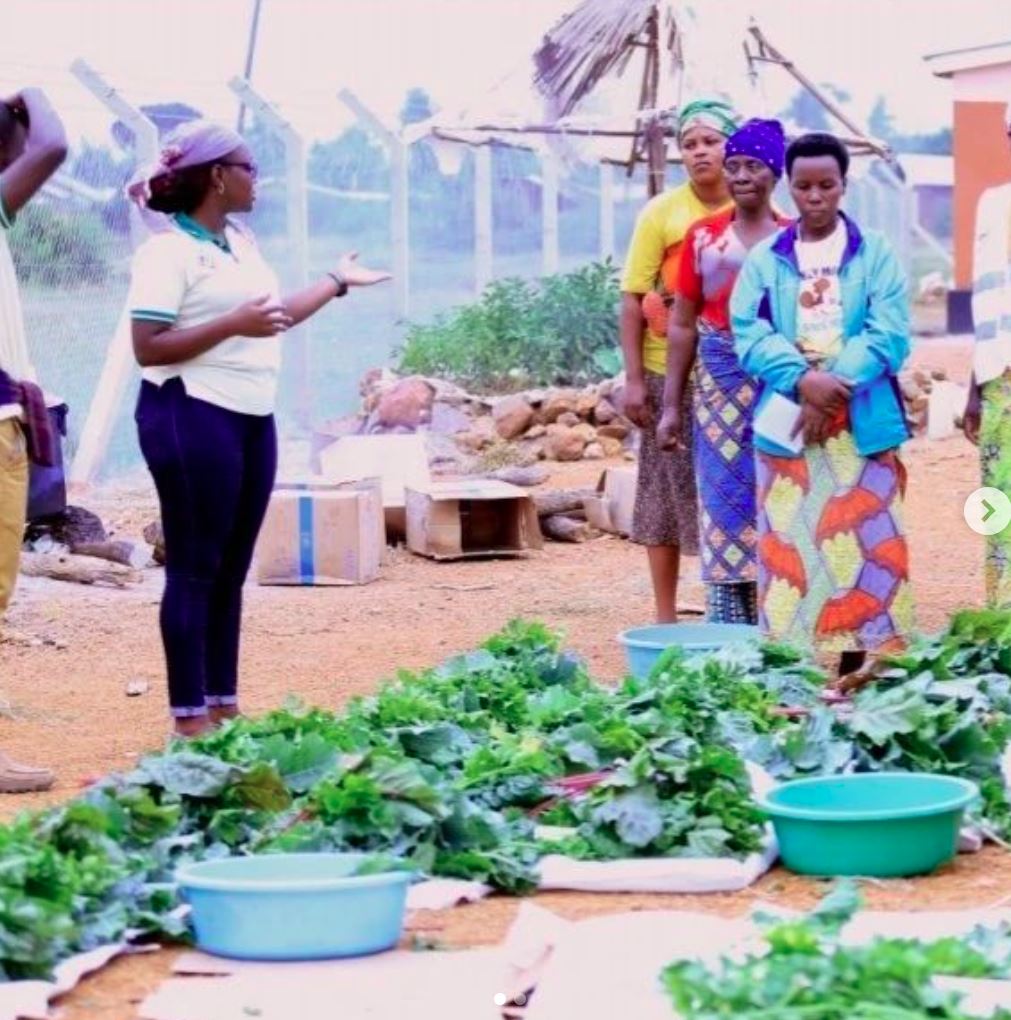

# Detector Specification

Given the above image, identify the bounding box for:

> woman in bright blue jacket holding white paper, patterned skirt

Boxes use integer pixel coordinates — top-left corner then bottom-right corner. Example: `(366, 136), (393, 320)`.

(730, 134), (914, 673)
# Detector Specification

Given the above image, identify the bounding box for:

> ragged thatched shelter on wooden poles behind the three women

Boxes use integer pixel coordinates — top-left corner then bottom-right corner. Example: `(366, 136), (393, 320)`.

(408, 0), (889, 194)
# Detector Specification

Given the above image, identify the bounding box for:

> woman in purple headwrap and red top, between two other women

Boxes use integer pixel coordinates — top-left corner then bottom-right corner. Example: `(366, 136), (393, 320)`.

(657, 120), (788, 624)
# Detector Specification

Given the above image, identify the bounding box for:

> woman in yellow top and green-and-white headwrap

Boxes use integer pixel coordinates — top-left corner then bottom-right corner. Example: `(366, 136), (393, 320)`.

(621, 99), (737, 623)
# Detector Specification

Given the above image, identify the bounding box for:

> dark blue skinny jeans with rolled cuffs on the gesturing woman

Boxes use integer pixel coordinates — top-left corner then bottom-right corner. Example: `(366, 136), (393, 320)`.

(137, 378), (277, 717)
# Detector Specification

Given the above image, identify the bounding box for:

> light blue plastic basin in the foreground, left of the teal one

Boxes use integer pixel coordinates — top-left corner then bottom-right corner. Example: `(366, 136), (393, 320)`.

(176, 854), (411, 960)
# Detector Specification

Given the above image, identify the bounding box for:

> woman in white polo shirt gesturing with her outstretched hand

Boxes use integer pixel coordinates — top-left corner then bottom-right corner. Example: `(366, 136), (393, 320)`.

(130, 121), (389, 736)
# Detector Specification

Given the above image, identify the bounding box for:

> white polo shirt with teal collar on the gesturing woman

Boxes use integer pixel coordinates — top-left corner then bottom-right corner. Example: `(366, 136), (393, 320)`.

(129, 215), (283, 415)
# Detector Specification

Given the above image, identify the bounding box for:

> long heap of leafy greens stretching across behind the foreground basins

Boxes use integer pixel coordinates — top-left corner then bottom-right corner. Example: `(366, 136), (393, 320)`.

(0, 613), (1011, 979)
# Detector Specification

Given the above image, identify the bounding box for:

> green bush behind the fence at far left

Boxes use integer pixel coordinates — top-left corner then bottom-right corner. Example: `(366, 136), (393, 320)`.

(10, 203), (119, 287)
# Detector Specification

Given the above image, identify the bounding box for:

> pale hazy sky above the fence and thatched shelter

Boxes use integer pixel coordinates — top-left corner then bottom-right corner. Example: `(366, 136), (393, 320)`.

(0, 0), (1011, 147)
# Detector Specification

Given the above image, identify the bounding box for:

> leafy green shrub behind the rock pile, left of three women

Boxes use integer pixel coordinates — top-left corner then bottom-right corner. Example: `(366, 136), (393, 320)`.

(398, 259), (621, 391)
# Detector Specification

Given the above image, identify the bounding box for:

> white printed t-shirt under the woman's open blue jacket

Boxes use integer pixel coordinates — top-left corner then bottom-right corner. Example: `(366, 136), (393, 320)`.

(796, 219), (847, 367)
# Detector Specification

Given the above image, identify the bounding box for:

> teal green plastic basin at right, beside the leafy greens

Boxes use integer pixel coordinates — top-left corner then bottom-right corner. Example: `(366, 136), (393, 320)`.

(758, 772), (979, 878)
